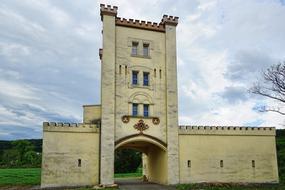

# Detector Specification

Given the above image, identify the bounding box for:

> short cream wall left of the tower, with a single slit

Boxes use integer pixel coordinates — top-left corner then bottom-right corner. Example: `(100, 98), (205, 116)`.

(41, 122), (99, 187)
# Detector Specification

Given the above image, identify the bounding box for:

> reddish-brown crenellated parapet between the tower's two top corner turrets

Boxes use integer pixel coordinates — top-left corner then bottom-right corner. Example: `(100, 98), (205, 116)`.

(116, 17), (165, 32)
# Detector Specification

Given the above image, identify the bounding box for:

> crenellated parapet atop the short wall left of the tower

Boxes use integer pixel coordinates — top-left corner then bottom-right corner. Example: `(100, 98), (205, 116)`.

(43, 122), (100, 133)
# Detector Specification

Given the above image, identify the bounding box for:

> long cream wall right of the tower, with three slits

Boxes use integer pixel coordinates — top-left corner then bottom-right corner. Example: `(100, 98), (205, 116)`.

(179, 126), (278, 183)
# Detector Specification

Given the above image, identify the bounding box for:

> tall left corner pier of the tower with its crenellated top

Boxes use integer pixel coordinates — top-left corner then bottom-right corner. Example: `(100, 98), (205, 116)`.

(100, 9), (116, 185)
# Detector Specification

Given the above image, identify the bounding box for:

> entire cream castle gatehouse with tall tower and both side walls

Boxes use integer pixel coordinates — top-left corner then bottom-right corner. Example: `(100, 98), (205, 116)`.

(41, 5), (278, 187)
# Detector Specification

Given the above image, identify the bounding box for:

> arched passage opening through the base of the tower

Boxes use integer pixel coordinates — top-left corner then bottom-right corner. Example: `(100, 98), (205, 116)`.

(115, 138), (167, 184)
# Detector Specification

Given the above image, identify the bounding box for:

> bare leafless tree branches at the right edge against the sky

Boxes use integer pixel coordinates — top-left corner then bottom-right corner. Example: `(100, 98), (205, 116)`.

(250, 61), (285, 115)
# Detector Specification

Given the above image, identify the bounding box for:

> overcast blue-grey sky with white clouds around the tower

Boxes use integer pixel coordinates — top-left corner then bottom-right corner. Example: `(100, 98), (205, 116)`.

(0, 0), (285, 140)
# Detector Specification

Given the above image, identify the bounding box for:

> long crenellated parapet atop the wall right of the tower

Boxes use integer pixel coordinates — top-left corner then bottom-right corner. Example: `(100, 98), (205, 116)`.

(179, 126), (276, 136)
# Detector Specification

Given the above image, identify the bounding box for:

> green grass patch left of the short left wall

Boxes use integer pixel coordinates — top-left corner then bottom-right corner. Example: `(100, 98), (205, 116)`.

(0, 168), (41, 186)
